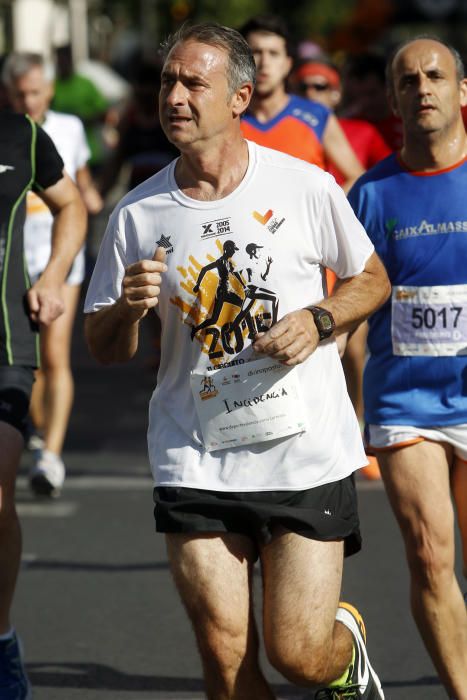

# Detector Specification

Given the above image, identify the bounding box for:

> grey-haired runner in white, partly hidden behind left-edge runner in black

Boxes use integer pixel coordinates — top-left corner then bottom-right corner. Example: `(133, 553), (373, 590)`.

(2, 52), (102, 496)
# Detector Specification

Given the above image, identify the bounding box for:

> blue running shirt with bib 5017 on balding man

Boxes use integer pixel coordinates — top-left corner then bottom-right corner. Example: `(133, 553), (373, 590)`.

(349, 155), (467, 426)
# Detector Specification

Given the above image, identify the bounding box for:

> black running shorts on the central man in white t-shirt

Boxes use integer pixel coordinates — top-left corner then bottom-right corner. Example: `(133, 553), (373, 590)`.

(154, 475), (362, 556)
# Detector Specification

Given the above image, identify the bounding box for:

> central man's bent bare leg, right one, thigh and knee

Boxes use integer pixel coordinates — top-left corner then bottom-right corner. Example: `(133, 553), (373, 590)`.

(261, 528), (353, 686)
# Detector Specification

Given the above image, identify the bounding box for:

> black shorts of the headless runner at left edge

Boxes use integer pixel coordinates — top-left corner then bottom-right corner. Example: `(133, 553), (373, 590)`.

(0, 365), (34, 437)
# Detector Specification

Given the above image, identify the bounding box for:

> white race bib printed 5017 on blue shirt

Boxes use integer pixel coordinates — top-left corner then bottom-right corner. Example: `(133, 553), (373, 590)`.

(391, 284), (467, 356)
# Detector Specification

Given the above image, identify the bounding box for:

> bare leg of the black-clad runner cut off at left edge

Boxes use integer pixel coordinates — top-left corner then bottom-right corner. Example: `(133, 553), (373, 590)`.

(0, 421), (23, 634)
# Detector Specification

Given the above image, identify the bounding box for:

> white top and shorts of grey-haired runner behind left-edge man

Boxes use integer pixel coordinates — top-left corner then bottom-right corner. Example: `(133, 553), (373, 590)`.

(24, 111), (91, 284)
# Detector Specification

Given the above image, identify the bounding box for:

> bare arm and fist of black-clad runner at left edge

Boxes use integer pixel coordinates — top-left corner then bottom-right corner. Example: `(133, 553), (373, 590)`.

(28, 174), (87, 325)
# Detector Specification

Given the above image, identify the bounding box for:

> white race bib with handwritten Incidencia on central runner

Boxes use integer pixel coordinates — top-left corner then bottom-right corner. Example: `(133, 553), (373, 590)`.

(191, 358), (307, 452)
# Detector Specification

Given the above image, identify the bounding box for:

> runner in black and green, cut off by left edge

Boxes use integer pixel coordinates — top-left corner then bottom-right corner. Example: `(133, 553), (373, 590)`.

(0, 112), (86, 700)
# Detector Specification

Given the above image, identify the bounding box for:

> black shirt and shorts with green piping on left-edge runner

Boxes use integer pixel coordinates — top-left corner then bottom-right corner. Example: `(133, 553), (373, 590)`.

(0, 111), (63, 429)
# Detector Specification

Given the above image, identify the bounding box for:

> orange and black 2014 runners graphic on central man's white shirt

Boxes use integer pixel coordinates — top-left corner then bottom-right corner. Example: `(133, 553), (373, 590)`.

(171, 239), (279, 366)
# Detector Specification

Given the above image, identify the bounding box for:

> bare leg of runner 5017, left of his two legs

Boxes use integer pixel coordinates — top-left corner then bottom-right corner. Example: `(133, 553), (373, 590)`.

(378, 441), (467, 700)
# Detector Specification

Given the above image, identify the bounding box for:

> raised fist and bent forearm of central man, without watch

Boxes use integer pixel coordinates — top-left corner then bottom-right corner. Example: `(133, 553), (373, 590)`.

(84, 247), (167, 364)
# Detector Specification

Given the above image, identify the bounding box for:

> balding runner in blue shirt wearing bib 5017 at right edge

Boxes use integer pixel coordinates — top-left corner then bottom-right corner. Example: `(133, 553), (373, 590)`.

(350, 38), (467, 700)
